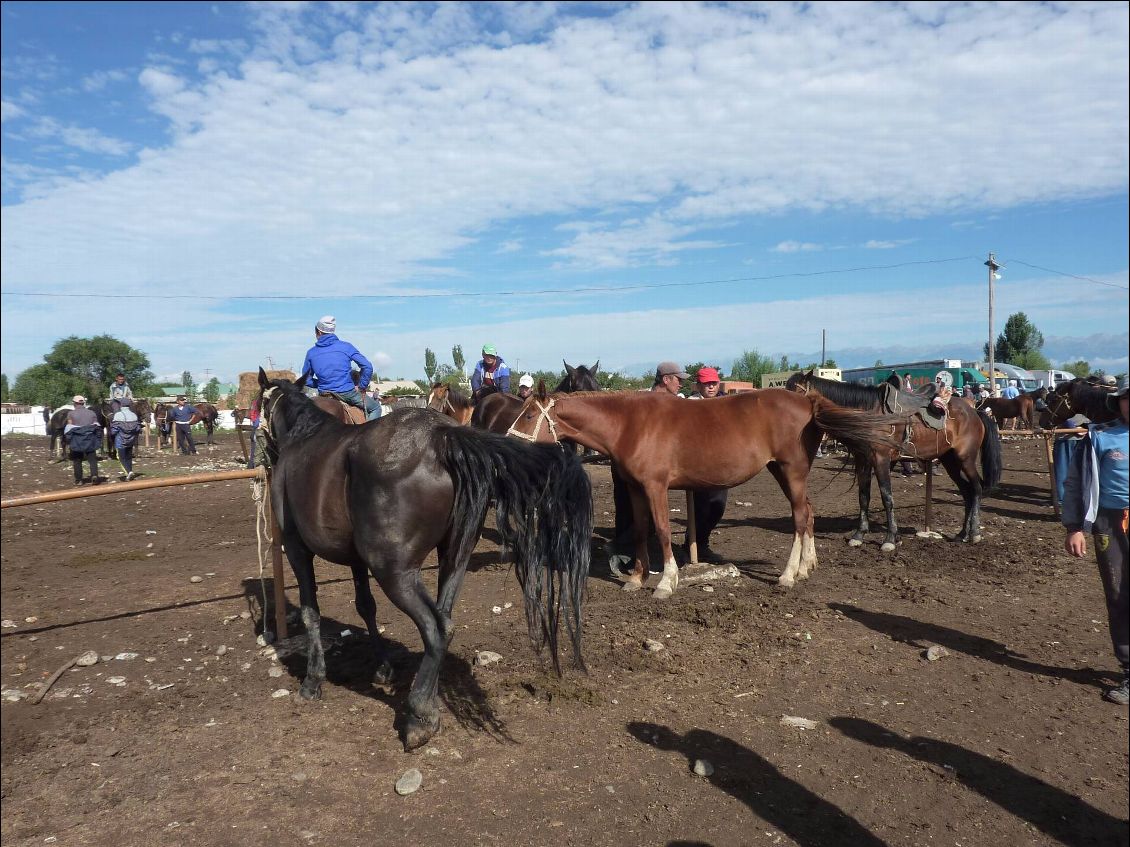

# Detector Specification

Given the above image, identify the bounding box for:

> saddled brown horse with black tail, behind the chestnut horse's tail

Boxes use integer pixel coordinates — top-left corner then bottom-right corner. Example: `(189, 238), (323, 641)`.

(785, 370), (1003, 552)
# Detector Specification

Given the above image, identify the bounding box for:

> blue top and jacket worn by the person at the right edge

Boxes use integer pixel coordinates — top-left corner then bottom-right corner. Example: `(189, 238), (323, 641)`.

(1060, 421), (1130, 530)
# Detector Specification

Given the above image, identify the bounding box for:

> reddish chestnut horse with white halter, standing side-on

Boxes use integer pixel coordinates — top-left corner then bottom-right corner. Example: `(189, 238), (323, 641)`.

(509, 383), (897, 600)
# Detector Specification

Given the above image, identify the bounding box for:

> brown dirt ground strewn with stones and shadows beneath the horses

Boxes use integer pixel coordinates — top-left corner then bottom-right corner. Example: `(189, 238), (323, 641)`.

(0, 434), (1128, 847)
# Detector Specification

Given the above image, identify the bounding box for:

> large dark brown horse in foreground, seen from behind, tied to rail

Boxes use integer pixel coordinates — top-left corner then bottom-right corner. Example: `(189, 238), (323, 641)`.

(259, 369), (592, 750)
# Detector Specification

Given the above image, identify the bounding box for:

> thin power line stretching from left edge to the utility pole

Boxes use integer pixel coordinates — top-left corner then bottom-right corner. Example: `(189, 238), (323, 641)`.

(2, 256), (976, 300)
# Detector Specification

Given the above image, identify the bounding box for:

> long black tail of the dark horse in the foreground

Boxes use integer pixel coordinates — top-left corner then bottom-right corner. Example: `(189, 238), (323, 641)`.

(437, 426), (592, 673)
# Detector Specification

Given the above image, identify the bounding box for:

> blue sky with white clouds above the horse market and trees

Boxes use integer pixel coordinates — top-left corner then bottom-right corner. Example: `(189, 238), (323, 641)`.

(0, 2), (1130, 379)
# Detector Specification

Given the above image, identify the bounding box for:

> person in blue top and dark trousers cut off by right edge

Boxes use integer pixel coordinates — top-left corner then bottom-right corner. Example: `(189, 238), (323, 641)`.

(1061, 379), (1130, 706)
